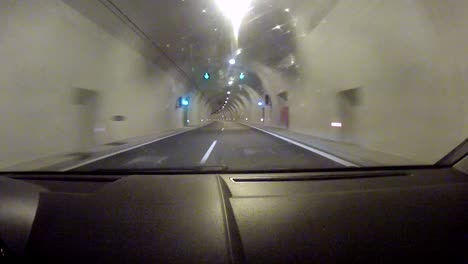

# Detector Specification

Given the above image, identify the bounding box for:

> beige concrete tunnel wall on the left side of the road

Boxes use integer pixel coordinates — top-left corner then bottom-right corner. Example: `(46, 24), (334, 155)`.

(0, 0), (207, 167)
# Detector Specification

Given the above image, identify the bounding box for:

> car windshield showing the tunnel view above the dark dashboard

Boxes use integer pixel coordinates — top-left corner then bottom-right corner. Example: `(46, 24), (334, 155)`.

(0, 0), (468, 172)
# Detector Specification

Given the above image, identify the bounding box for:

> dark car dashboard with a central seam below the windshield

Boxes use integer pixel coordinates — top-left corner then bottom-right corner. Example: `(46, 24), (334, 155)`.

(0, 167), (468, 263)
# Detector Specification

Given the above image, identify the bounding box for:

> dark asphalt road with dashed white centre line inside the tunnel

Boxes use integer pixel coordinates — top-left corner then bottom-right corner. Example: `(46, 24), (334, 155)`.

(74, 122), (345, 171)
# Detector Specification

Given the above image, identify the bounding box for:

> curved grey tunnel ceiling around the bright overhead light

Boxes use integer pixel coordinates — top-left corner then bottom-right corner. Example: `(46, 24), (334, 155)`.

(77, 0), (336, 112)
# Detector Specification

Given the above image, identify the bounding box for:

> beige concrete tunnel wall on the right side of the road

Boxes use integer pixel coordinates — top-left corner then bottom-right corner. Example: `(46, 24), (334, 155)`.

(240, 0), (468, 164)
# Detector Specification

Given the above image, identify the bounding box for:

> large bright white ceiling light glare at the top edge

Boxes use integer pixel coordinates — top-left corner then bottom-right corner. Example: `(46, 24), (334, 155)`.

(216, 0), (252, 42)
